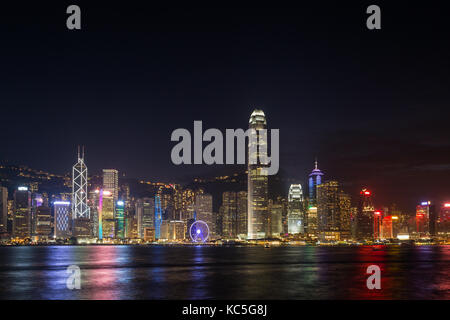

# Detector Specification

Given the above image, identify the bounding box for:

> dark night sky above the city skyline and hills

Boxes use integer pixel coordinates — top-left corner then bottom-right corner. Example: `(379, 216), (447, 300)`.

(0, 1), (450, 208)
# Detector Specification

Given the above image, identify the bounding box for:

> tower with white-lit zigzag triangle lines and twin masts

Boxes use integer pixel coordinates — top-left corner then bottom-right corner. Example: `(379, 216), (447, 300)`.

(72, 147), (89, 220)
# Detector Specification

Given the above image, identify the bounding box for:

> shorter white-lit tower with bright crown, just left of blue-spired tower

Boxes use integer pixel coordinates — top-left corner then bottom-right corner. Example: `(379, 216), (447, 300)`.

(288, 184), (305, 234)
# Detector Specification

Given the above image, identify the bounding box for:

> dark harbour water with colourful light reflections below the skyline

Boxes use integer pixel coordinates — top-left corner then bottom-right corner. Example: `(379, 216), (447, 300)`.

(0, 245), (450, 300)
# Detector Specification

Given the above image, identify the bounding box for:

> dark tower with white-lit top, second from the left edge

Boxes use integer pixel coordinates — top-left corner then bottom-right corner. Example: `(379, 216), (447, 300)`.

(13, 187), (31, 240)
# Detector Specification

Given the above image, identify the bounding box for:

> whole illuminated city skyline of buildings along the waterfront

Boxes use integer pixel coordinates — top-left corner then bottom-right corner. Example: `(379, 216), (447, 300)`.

(0, 109), (450, 245)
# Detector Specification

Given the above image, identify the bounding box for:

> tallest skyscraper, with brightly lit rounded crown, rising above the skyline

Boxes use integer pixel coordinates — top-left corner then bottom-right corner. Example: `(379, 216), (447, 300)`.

(248, 110), (268, 239)
